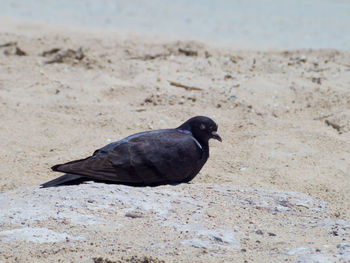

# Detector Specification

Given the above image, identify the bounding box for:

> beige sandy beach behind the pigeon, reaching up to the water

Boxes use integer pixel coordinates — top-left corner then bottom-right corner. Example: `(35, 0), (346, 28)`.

(0, 19), (350, 262)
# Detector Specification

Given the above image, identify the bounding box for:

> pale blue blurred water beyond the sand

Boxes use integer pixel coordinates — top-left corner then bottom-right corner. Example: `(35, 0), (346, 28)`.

(0, 0), (350, 50)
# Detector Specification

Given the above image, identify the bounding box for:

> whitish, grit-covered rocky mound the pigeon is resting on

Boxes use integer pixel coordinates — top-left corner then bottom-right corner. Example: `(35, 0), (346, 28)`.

(0, 183), (350, 262)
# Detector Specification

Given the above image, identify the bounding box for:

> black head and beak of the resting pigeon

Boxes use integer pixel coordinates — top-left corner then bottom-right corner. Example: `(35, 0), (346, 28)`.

(178, 116), (222, 142)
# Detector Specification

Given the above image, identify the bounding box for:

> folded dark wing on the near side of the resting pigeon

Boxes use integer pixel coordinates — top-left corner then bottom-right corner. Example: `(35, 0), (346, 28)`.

(53, 130), (202, 185)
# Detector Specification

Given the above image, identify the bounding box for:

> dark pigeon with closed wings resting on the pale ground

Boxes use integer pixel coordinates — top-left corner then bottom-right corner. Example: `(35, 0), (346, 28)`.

(41, 116), (222, 187)
